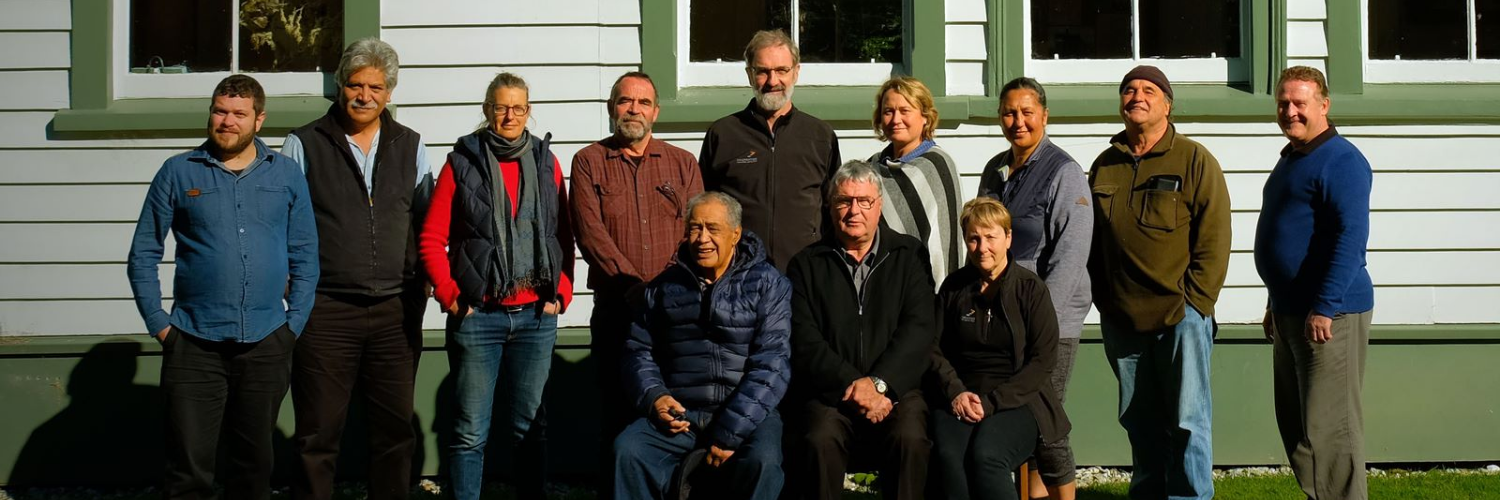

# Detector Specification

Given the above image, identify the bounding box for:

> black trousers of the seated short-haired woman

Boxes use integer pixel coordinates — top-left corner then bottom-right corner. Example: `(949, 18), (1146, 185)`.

(932, 407), (1037, 500)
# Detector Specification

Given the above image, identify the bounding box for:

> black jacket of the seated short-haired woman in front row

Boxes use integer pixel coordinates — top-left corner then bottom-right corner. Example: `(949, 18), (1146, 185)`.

(933, 263), (1071, 441)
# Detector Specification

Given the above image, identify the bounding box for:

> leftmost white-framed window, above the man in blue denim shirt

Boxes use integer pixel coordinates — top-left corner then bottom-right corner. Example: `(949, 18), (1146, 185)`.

(113, 0), (344, 98)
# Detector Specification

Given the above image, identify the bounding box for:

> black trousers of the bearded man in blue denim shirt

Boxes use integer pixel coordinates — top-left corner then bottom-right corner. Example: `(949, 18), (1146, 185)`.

(162, 324), (296, 500)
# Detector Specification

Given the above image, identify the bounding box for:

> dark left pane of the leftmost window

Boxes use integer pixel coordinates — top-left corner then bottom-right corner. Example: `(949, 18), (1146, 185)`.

(131, 0), (233, 72)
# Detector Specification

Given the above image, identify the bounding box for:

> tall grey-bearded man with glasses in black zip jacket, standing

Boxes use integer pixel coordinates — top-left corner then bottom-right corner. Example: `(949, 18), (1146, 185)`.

(698, 30), (840, 272)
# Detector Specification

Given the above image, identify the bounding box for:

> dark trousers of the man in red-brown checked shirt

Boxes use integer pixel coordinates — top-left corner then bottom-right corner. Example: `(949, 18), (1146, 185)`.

(588, 294), (641, 500)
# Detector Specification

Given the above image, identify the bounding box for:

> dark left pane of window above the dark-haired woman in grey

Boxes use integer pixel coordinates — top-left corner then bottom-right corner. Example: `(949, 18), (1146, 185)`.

(1032, 0), (1131, 59)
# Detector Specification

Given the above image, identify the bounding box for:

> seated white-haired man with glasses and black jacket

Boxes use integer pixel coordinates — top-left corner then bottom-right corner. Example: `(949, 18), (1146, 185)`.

(785, 161), (935, 500)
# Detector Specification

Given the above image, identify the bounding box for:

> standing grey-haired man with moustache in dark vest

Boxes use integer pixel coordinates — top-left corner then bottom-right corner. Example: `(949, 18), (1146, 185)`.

(282, 38), (432, 500)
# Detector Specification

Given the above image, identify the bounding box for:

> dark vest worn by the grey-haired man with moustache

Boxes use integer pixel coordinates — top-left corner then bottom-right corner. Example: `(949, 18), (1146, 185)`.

(293, 104), (426, 297)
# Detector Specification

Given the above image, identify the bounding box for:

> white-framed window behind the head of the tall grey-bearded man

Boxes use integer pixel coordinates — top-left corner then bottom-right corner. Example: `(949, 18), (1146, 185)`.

(677, 0), (905, 87)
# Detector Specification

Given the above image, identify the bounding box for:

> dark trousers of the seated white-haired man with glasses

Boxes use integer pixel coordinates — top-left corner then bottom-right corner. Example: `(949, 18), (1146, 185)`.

(782, 390), (933, 500)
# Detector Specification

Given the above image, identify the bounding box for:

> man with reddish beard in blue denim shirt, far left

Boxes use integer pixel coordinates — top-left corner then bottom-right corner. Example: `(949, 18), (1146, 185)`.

(126, 75), (318, 498)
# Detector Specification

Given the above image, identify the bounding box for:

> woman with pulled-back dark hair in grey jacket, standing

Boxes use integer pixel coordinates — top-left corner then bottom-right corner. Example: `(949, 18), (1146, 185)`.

(980, 77), (1094, 500)
